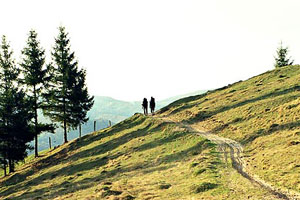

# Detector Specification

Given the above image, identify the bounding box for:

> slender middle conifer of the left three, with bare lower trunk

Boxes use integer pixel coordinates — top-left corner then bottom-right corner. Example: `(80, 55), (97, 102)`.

(21, 30), (54, 157)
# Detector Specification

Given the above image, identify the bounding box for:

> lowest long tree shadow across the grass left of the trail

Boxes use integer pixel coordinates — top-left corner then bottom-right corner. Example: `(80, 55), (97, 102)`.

(9, 140), (210, 200)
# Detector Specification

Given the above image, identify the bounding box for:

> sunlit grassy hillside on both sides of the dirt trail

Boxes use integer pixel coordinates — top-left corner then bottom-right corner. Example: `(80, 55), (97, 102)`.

(0, 66), (300, 200)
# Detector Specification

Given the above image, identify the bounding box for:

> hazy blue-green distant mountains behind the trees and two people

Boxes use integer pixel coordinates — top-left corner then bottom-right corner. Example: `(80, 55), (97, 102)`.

(30, 90), (206, 154)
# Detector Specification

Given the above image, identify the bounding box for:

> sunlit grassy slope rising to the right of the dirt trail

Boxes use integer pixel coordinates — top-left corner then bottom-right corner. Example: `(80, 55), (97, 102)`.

(161, 66), (300, 191)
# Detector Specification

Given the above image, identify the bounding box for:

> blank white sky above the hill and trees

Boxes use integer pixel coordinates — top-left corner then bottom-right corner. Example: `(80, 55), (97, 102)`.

(0, 0), (300, 100)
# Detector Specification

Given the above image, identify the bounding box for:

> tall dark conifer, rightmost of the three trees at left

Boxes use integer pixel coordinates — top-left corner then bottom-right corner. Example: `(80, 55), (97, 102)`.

(44, 27), (94, 143)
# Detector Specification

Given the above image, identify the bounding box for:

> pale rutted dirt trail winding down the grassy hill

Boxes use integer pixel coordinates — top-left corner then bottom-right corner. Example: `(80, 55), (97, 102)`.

(159, 118), (300, 200)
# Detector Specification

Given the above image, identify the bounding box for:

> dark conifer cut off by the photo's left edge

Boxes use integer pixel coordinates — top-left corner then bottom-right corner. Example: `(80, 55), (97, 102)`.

(0, 36), (33, 172)
